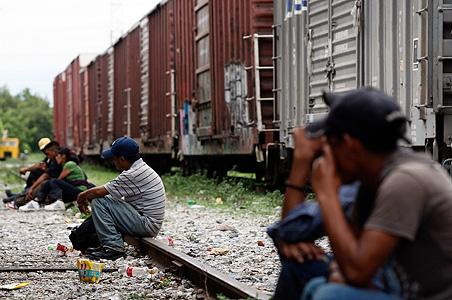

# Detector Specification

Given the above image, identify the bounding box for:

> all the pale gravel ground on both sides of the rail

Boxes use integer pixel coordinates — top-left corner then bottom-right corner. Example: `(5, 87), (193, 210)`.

(0, 196), (280, 300)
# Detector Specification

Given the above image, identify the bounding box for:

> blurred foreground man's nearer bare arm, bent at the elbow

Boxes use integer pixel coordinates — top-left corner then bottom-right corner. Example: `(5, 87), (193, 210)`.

(313, 146), (400, 286)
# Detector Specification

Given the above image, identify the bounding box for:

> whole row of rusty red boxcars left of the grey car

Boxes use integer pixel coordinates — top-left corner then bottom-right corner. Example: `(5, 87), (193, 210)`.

(55, 0), (279, 175)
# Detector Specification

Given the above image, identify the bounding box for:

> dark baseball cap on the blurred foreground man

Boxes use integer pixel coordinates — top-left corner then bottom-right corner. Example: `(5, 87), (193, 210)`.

(306, 87), (410, 148)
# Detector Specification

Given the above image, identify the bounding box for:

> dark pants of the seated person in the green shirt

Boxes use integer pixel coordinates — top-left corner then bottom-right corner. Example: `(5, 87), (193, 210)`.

(36, 179), (81, 203)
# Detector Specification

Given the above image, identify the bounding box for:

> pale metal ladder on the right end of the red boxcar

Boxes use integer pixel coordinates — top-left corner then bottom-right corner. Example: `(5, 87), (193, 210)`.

(243, 33), (279, 131)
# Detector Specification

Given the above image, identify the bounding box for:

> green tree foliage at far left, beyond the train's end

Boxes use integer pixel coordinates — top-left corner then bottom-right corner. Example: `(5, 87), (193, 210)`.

(0, 87), (53, 151)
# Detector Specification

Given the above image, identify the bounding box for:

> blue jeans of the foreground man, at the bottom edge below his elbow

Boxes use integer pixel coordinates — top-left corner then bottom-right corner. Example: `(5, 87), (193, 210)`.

(301, 277), (401, 300)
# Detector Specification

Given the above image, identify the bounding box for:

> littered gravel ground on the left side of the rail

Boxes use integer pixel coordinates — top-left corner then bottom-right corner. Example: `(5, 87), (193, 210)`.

(0, 209), (203, 300)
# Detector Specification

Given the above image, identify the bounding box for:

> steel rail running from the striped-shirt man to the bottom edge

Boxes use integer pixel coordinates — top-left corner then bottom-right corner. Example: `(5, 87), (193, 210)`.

(126, 237), (270, 300)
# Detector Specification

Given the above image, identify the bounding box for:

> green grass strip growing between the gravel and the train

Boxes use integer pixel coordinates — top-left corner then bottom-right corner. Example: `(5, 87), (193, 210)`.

(0, 153), (283, 215)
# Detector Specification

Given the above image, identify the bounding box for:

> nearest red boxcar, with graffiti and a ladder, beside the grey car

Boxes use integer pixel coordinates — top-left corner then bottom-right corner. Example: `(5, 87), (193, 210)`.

(176, 0), (277, 173)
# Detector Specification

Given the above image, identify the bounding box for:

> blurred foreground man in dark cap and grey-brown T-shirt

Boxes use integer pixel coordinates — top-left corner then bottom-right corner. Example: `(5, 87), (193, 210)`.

(289, 88), (452, 300)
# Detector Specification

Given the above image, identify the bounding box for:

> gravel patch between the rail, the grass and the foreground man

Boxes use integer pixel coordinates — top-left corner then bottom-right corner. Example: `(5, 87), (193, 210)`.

(159, 203), (280, 294)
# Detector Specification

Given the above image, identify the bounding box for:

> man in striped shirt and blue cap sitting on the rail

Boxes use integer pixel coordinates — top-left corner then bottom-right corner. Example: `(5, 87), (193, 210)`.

(77, 137), (166, 260)
